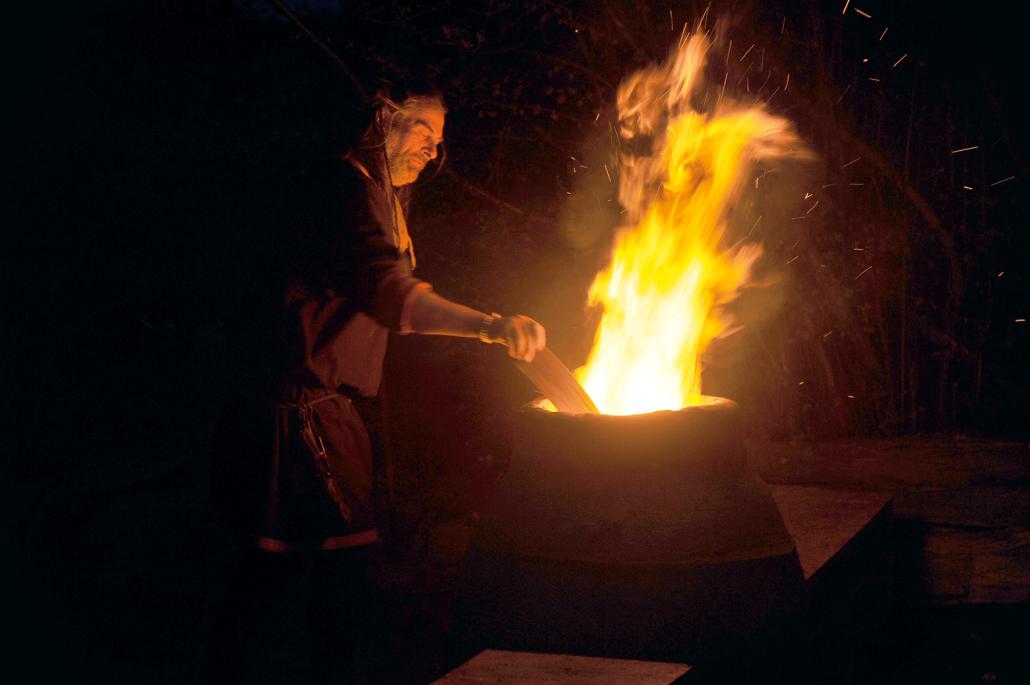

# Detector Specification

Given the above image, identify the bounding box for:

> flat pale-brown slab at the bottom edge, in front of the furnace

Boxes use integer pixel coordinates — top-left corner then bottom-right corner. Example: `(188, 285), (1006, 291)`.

(435, 649), (690, 685)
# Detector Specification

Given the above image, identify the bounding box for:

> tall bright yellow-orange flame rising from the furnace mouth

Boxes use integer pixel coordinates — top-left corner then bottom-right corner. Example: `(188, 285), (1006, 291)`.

(576, 29), (799, 414)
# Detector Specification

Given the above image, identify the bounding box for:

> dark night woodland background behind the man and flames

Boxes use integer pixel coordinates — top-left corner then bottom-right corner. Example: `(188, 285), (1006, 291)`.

(3, 0), (1030, 682)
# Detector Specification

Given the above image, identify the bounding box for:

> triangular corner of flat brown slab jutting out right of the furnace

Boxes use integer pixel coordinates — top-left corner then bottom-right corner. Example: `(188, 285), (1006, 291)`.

(769, 485), (891, 581)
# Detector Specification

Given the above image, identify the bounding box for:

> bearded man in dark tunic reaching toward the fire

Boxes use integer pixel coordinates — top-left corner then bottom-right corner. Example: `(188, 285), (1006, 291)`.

(202, 85), (546, 682)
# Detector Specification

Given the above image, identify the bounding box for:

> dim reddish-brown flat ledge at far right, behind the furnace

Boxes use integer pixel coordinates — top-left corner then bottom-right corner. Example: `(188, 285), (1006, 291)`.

(748, 436), (1030, 605)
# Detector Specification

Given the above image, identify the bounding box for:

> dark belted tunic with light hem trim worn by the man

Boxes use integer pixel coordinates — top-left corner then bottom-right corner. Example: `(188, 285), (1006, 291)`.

(213, 156), (428, 550)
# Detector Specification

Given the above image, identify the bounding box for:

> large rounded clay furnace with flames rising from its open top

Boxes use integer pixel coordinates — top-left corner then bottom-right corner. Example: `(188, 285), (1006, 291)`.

(455, 397), (803, 673)
